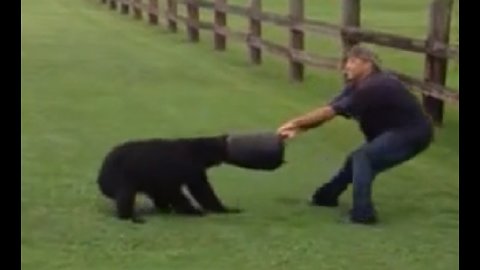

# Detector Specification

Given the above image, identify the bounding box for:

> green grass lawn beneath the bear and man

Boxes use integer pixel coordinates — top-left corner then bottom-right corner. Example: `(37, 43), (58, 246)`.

(21, 0), (459, 270)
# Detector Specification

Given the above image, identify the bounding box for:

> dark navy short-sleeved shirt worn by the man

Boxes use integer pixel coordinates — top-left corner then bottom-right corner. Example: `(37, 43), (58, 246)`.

(330, 72), (432, 141)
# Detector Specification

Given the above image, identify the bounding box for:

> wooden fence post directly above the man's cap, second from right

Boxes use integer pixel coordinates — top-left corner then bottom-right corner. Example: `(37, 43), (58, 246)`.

(342, 0), (361, 59)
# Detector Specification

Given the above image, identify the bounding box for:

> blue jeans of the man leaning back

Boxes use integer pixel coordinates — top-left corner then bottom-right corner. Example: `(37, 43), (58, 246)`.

(314, 128), (432, 219)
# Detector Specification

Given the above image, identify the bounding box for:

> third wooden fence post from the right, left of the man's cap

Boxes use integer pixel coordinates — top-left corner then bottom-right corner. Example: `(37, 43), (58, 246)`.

(290, 0), (305, 81)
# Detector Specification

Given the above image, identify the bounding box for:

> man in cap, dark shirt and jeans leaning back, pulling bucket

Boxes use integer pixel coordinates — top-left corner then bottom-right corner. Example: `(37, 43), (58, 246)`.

(277, 46), (433, 224)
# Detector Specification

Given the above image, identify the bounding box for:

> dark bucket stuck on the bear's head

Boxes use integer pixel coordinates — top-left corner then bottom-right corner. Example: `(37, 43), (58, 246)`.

(226, 132), (285, 170)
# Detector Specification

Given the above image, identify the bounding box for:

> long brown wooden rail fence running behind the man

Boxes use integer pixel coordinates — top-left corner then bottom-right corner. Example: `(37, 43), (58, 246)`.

(101, 0), (459, 125)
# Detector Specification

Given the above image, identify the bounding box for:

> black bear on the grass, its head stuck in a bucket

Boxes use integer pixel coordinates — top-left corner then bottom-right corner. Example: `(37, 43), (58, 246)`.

(97, 136), (240, 223)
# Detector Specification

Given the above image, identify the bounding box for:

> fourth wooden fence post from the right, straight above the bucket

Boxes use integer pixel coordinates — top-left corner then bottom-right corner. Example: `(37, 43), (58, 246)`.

(248, 0), (262, 65)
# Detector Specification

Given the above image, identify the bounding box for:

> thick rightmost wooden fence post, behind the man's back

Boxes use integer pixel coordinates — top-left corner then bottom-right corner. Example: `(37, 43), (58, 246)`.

(423, 0), (453, 126)
